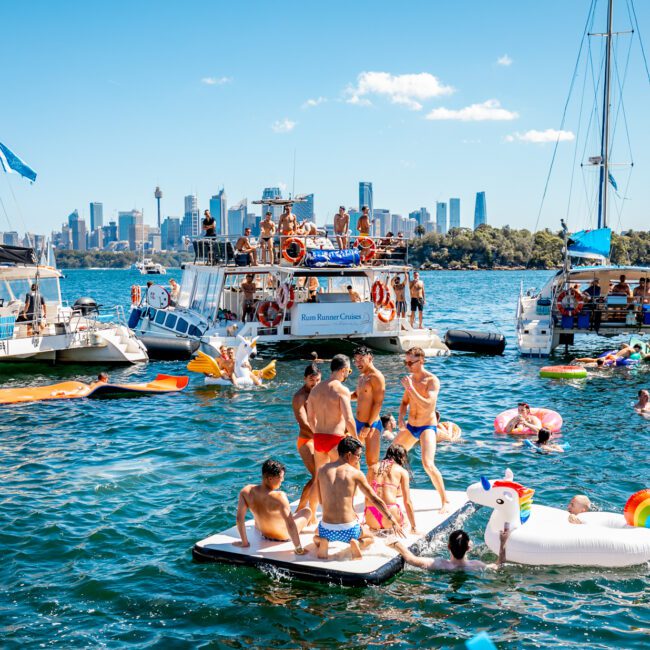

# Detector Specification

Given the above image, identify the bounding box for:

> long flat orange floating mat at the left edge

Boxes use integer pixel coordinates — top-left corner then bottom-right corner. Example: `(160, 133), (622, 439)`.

(0, 375), (189, 404)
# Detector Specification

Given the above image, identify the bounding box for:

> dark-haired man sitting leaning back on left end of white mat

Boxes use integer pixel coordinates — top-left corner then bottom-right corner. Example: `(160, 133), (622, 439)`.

(233, 459), (311, 555)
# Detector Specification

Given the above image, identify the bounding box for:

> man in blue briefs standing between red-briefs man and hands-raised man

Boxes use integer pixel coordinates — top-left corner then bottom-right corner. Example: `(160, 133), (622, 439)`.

(352, 346), (386, 467)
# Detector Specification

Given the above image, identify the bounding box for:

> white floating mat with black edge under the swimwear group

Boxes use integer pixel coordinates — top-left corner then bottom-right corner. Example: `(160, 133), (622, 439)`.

(192, 490), (471, 586)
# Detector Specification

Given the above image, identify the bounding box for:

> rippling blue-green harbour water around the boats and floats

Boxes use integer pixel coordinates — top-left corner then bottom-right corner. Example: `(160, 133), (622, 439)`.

(0, 271), (650, 648)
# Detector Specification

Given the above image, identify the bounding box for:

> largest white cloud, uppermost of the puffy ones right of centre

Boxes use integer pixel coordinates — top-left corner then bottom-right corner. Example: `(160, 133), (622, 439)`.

(346, 72), (454, 111)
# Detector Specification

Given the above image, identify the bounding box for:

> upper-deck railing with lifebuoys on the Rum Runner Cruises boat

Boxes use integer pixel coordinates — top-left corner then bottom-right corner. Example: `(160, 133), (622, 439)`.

(192, 234), (408, 266)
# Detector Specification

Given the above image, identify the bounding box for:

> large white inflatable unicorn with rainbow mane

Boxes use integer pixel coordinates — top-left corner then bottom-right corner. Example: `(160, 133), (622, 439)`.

(467, 469), (650, 567)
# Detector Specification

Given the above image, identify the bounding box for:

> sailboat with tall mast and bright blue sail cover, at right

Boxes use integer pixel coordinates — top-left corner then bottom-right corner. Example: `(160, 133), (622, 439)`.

(516, 0), (650, 357)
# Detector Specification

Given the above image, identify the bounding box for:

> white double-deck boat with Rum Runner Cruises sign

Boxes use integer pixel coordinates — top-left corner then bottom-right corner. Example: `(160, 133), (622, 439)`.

(129, 230), (449, 357)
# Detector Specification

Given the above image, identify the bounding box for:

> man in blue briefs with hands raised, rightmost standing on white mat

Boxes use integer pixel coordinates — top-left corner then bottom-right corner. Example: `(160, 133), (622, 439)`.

(393, 348), (449, 513)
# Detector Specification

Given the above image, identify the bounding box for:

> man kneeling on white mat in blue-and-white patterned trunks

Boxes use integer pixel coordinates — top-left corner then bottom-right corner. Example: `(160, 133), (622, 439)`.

(314, 436), (405, 560)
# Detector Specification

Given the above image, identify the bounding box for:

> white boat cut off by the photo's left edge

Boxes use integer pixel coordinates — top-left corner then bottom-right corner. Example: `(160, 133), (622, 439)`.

(0, 246), (148, 363)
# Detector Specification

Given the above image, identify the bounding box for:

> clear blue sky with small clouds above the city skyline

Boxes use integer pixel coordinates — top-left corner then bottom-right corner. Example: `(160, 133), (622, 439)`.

(0, 0), (650, 232)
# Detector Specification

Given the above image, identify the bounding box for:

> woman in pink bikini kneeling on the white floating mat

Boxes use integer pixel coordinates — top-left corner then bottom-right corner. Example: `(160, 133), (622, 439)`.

(364, 445), (416, 532)
